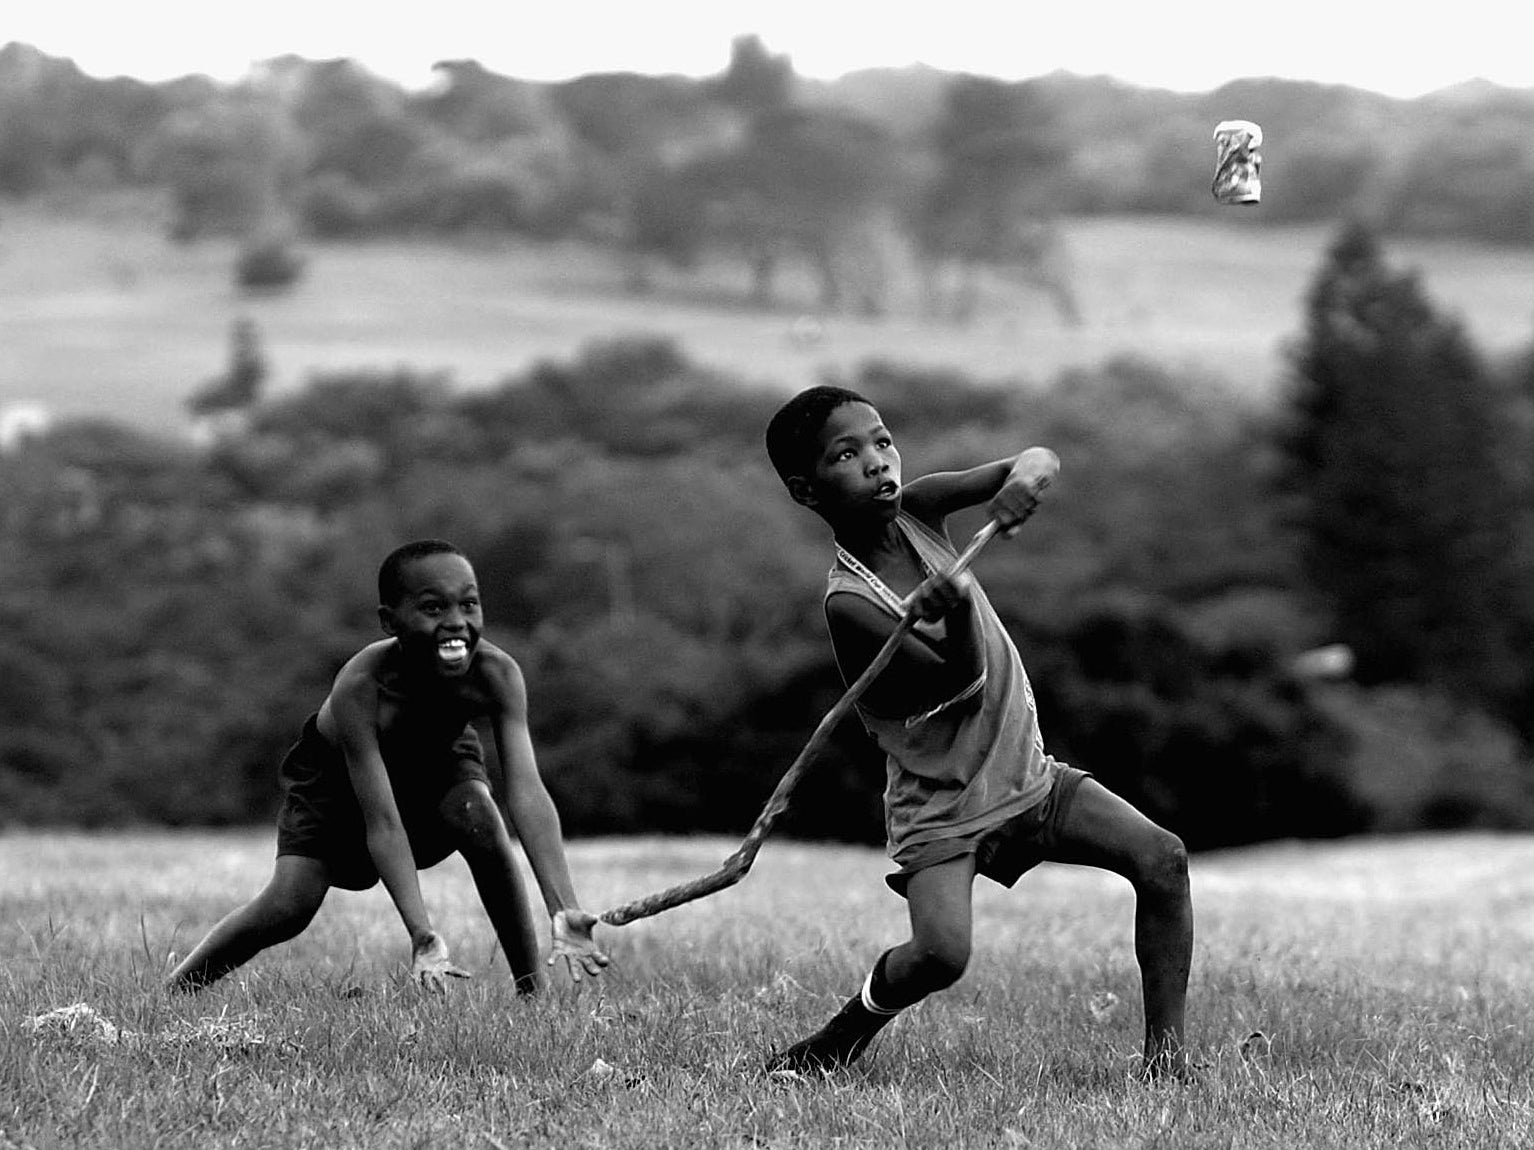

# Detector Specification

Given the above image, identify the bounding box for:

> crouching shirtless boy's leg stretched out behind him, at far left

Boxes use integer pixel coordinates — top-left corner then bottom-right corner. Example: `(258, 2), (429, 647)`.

(167, 854), (330, 992)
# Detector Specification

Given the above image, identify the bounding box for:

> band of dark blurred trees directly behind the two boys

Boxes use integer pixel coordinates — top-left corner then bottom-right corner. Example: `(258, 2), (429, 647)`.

(0, 227), (1534, 848)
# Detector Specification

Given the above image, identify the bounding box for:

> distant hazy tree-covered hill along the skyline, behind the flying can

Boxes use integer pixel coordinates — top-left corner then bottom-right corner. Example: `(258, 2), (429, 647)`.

(0, 35), (1534, 322)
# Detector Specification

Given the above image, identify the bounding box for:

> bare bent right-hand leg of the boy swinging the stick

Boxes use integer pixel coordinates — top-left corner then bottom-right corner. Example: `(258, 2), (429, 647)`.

(1045, 779), (1193, 1073)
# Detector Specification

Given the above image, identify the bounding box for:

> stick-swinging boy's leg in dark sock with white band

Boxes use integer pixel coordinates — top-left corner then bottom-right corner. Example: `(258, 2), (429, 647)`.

(767, 854), (974, 1072)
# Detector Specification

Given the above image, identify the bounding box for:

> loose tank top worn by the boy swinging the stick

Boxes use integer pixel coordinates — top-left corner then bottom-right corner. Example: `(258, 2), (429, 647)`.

(825, 512), (1052, 862)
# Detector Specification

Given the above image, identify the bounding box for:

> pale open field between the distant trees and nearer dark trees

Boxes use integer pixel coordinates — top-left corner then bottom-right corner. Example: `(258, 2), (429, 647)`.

(9, 197), (1534, 426)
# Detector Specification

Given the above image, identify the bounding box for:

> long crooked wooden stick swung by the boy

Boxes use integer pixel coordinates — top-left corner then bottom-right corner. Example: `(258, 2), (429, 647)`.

(601, 520), (1000, 926)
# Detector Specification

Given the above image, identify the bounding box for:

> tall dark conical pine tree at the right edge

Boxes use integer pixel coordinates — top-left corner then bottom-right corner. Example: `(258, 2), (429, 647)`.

(1284, 225), (1516, 704)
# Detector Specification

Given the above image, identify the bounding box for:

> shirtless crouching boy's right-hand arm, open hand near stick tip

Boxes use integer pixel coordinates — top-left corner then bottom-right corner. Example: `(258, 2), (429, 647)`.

(483, 650), (607, 980)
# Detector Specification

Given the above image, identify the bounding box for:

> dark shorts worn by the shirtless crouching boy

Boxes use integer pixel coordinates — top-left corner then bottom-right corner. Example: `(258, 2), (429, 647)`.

(278, 716), (489, 891)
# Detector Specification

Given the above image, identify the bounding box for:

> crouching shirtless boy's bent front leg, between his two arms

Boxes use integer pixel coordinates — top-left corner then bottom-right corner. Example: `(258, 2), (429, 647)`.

(437, 779), (540, 994)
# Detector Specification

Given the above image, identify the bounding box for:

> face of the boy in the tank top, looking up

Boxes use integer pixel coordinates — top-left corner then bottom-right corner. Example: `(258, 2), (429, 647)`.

(790, 403), (900, 520)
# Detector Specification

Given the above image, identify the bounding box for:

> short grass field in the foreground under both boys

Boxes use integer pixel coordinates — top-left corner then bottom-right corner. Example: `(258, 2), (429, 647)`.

(0, 833), (1534, 1150)
